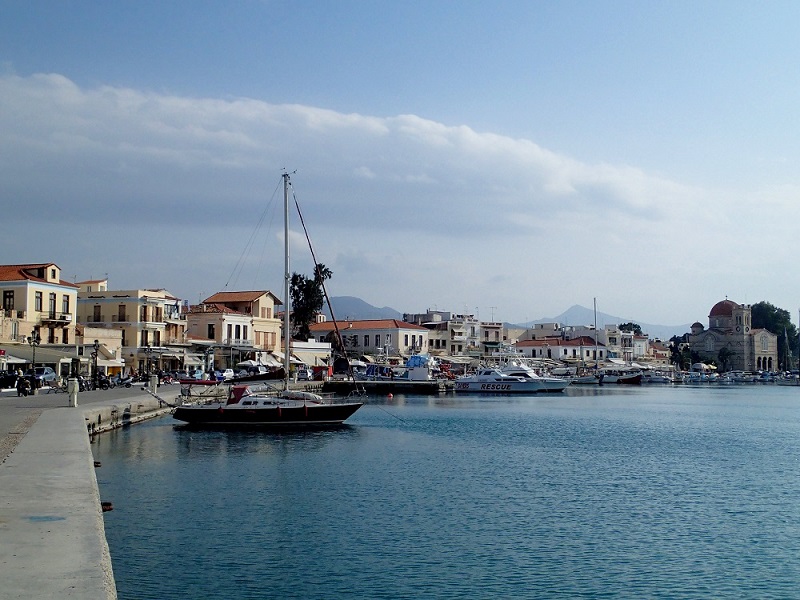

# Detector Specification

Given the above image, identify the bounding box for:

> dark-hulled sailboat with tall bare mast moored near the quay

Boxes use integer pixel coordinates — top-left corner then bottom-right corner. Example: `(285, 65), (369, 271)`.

(172, 173), (364, 428)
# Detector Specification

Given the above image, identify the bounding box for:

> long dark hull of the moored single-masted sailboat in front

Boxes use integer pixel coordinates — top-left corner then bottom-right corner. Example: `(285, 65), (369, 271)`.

(172, 402), (363, 428)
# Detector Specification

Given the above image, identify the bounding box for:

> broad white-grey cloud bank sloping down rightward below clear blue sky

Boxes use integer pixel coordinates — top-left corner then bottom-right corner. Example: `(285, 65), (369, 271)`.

(0, 74), (800, 322)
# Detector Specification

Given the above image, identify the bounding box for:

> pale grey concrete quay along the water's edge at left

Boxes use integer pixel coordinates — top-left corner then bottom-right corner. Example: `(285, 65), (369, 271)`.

(0, 386), (175, 600)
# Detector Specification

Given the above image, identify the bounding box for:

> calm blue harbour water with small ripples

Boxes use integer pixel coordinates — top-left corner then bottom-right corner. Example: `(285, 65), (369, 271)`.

(93, 386), (800, 600)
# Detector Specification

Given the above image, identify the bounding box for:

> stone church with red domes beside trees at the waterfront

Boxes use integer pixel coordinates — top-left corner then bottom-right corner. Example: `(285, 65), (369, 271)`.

(689, 298), (778, 371)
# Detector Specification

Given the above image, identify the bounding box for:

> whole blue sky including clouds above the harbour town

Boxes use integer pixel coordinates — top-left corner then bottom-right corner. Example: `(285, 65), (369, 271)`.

(0, 0), (800, 325)
